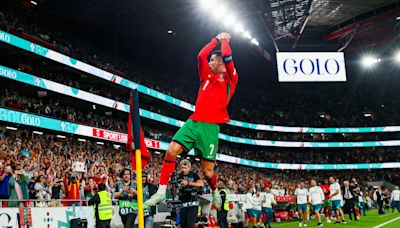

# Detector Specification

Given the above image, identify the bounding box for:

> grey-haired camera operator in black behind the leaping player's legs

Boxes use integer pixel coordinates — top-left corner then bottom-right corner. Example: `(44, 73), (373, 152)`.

(178, 159), (204, 228)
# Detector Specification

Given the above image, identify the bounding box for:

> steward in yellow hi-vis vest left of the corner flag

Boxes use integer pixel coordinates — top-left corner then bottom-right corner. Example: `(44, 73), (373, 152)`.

(89, 183), (113, 228)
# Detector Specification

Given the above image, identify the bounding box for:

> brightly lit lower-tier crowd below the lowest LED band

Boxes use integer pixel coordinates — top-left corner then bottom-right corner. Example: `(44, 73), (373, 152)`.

(0, 127), (400, 206)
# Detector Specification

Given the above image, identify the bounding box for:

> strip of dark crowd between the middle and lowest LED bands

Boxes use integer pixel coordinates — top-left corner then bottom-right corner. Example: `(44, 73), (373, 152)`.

(0, 89), (397, 164)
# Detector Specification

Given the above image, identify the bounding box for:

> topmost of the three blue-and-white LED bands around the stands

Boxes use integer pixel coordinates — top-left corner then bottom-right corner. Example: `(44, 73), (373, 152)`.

(0, 30), (400, 134)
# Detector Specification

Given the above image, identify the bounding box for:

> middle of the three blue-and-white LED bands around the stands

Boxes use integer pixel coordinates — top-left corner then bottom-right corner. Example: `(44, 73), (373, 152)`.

(0, 66), (400, 148)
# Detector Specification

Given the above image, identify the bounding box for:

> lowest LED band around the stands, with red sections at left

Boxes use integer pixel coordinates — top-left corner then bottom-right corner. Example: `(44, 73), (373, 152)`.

(0, 108), (400, 170)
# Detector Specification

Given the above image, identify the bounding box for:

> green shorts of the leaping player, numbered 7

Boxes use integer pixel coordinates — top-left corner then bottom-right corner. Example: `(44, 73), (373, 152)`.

(172, 119), (220, 161)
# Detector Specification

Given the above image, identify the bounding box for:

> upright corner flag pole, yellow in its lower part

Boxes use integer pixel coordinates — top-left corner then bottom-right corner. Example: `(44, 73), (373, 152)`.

(131, 88), (144, 228)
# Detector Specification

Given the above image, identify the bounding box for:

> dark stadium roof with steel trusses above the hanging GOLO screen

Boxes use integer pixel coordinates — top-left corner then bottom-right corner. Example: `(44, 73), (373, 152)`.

(19, 0), (400, 84)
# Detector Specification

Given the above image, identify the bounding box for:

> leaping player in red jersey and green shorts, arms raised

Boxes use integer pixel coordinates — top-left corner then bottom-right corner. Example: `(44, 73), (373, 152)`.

(145, 32), (238, 208)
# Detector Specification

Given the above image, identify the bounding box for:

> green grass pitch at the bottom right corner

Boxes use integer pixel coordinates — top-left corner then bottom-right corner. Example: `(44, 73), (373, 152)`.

(264, 211), (400, 228)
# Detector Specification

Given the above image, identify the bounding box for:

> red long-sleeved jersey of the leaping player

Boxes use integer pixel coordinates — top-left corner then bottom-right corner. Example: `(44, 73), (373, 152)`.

(190, 38), (238, 124)
